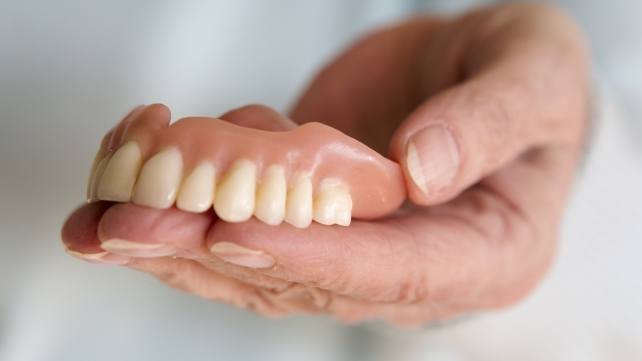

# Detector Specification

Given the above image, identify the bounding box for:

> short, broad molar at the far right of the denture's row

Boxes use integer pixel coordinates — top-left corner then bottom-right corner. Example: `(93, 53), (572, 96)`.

(314, 178), (352, 226)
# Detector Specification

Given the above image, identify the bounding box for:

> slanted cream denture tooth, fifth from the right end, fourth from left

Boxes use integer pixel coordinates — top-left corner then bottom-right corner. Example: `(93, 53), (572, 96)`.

(176, 162), (216, 213)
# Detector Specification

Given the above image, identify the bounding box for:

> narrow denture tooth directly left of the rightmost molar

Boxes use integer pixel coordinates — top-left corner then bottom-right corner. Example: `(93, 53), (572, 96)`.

(285, 175), (312, 228)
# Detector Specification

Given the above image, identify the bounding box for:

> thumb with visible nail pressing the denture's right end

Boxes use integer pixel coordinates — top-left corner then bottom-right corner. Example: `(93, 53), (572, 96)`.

(390, 79), (561, 205)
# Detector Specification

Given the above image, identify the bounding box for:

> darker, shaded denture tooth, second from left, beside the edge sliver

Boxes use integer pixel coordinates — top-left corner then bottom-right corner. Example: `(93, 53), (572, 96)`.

(98, 141), (142, 202)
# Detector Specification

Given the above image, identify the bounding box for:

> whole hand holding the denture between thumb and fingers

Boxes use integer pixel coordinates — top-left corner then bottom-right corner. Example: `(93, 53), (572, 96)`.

(63, 5), (588, 325)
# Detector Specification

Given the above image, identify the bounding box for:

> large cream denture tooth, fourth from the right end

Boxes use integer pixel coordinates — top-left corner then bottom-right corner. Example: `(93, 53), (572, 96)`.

(214, 159), (256, 222)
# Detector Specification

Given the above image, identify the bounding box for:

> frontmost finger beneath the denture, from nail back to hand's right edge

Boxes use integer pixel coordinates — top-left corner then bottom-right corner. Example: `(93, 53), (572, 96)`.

(207, 148), (572, 312)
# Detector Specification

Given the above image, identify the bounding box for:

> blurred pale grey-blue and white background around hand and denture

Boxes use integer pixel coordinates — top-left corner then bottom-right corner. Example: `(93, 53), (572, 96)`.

(0, 0), (642, 361)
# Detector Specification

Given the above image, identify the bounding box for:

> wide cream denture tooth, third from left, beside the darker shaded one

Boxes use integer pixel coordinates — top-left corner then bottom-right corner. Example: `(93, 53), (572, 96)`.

(132, 147), (183, 209)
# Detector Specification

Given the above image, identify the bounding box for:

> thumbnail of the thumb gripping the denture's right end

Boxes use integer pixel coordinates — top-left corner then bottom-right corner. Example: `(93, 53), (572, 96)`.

(406, 125), (460, 194)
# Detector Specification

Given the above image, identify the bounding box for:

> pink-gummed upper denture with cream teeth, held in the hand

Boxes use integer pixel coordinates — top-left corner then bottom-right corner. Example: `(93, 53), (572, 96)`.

(88, 114), (406, 228)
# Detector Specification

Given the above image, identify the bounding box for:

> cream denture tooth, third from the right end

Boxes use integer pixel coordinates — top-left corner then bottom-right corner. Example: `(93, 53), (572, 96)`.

(254, 165), (287, 226)
